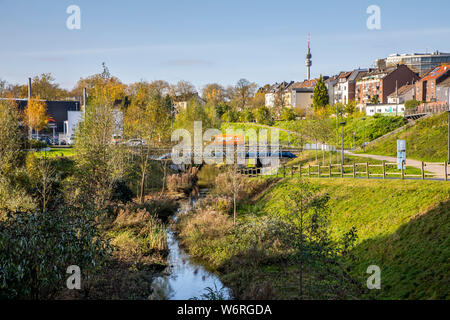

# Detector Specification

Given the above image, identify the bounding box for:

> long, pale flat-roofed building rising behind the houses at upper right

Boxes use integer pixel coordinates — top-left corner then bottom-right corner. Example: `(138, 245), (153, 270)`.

(382, 51), (450, 76)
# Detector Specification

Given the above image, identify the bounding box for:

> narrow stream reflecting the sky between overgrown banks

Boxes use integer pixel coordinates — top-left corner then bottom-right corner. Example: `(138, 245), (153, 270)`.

(151, 192), (230, 300)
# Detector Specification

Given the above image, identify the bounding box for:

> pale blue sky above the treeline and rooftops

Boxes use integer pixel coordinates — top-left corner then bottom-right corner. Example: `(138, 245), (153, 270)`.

(0, 0), (450, 89)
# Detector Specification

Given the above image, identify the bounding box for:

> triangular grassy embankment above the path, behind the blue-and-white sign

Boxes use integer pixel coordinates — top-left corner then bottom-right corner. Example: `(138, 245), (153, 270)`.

(366, 113), (448, 162)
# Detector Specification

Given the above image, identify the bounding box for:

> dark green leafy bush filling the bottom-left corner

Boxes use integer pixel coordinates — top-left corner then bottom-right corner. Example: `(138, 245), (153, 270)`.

(0, 209), (111, 299)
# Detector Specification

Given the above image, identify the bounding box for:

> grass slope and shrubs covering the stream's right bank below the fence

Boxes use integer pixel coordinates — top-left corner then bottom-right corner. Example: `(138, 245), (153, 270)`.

(178, 174), (450, 299)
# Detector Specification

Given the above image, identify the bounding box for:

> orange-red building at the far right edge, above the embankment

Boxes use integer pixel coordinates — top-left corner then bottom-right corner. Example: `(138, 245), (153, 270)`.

(416, 65), (450, 102)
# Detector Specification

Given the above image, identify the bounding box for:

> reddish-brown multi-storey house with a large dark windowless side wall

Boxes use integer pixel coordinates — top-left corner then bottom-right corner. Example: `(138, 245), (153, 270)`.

(355, 65), (419, 105)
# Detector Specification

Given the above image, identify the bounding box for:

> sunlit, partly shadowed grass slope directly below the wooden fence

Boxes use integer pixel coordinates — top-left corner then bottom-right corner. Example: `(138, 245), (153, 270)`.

(246, 179), (450, 299)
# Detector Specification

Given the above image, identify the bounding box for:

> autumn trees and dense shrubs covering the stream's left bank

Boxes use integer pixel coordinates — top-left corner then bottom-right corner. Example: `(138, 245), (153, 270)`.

(0, 85), (177, 299)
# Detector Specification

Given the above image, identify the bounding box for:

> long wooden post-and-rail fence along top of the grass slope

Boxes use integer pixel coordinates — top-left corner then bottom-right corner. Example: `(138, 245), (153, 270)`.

(238, 161), (449, 181)
